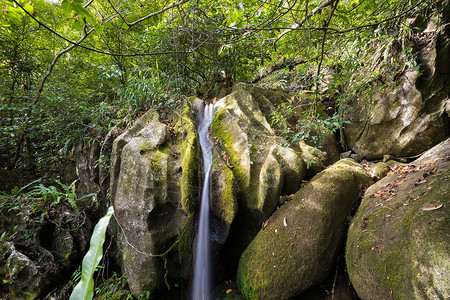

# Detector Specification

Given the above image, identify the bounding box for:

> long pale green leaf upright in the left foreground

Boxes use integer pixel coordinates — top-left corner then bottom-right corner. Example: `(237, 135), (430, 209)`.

(69, 206), (114, 300)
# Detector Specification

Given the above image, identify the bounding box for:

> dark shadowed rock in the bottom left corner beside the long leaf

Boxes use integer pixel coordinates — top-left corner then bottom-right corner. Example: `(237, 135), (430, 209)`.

(0, 204), (92, 300)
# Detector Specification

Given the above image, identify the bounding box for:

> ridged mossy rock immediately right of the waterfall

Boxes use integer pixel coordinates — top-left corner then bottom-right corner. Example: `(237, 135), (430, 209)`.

(211, 84), (306, 268)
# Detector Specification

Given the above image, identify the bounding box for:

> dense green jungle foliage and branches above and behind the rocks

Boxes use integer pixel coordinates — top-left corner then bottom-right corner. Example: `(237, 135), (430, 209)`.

(0, 0), (441, 299)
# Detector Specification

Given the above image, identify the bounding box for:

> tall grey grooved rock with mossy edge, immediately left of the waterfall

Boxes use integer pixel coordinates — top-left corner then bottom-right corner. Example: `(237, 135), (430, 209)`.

(111, 106), (198, 297)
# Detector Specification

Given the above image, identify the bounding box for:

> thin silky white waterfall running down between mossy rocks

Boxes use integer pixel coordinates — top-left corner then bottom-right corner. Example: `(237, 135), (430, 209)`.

(192, 104), (214, 300)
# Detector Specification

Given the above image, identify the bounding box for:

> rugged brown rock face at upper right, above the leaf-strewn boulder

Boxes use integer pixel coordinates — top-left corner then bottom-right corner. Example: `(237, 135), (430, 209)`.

(345, 7), (450, 160)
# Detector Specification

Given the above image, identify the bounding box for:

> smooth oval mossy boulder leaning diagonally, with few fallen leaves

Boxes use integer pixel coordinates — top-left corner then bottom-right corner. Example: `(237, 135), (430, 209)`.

(237, 159), (372, 299)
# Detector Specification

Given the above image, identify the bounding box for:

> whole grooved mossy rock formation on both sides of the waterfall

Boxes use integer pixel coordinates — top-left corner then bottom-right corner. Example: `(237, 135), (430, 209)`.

(110, 84), (342, 296)
